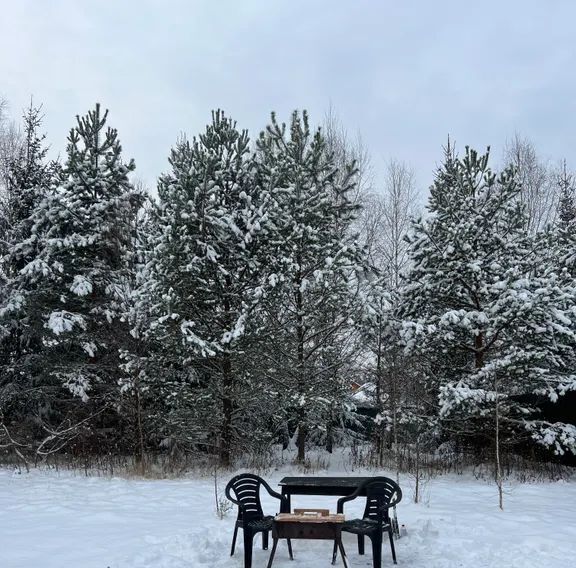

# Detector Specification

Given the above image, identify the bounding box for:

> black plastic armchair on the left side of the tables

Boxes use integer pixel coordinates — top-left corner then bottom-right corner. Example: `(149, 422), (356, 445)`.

(225, 473), (294, 568)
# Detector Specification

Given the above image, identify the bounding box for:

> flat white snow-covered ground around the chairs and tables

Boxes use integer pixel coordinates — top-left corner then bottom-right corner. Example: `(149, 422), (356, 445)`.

(0, 468), (576, 568)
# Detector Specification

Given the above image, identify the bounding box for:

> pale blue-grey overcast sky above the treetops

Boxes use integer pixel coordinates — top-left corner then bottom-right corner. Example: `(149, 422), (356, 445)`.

(0, 0), (576, 193)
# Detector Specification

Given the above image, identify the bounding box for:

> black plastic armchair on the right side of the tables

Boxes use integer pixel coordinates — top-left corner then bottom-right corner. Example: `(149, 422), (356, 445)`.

(332, 477), (402, 568)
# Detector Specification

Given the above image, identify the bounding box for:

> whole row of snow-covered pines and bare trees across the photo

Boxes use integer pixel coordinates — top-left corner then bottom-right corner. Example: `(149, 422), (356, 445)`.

(0, 94), (576, 492)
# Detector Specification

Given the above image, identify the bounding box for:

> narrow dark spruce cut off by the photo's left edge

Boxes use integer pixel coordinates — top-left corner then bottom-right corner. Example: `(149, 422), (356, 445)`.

(0, 105), (57, 444)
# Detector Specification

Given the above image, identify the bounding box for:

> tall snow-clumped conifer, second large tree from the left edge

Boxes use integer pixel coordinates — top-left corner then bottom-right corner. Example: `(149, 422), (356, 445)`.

(18, 104), (143, 430)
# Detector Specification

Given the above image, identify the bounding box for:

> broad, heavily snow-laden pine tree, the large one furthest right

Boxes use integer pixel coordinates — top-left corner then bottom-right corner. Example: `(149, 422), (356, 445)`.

(403, 144), (576, 486)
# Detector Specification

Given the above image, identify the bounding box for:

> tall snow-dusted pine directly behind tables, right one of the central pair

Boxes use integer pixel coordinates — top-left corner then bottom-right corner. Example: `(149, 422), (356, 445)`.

(258, 112), (365, 461)
